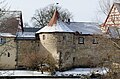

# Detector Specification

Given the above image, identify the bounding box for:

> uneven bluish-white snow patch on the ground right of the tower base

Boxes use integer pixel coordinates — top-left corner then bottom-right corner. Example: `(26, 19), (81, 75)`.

(55, 68), (108, 76)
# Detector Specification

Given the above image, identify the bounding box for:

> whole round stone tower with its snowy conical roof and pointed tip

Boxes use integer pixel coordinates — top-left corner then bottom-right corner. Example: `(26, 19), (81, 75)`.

(36, 10), (74, 69)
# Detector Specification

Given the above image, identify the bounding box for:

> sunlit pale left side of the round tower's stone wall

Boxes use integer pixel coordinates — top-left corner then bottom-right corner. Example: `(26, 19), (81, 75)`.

(39, 33), (59, 67)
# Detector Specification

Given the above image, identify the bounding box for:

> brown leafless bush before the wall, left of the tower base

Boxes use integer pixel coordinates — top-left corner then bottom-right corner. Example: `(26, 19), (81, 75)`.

(23, 52), (54, 74)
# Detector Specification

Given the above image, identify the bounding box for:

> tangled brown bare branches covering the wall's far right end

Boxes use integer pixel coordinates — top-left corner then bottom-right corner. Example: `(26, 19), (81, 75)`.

(93, 36), (120, 79)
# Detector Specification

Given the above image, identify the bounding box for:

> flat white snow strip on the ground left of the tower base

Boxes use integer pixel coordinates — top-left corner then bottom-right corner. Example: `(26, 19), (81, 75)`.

(0, 70), (50, 76)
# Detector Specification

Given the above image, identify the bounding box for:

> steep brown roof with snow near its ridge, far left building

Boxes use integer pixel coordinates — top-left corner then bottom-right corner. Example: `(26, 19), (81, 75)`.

(0, 11), (23, 35)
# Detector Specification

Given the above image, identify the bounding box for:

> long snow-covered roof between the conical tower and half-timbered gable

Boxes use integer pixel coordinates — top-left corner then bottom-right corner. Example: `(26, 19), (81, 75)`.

(66, 22), (102, 34)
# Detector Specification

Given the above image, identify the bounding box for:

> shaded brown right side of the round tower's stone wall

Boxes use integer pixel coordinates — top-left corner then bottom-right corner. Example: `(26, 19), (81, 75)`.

(56, 33), (76, 69)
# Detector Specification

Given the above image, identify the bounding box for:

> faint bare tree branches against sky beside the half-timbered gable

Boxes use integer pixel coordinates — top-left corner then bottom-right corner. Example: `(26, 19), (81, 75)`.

(93, 0), (120, 23)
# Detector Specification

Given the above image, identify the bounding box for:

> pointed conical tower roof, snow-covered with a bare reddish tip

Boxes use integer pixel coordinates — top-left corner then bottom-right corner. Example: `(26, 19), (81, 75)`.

(36, 10), (74, 33)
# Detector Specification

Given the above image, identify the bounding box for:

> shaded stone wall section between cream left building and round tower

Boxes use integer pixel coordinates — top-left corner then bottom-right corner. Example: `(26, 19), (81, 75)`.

(16, 39), (39, 66)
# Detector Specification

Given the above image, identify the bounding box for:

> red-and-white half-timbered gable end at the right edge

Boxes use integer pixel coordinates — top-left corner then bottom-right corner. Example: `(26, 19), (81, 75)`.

(103, 3), (120, 38)
